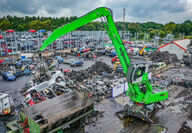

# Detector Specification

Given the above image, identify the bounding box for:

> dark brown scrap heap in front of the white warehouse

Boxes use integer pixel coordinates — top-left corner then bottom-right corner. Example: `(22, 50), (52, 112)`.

(149, 51), (178, 64)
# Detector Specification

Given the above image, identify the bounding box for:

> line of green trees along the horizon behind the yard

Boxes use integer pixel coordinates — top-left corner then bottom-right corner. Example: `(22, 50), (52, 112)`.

(0, 15), (192, 38)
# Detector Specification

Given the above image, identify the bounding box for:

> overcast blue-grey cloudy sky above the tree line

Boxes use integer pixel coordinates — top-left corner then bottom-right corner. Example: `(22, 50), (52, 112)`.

(0, 0), (192, 24)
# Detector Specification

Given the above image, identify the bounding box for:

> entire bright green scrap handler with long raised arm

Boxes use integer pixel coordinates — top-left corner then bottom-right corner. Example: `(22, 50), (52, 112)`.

(6, 7), (168, 132)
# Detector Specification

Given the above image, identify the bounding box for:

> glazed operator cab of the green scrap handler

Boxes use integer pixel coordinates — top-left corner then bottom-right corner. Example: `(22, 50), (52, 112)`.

(127, 62), (149, 83)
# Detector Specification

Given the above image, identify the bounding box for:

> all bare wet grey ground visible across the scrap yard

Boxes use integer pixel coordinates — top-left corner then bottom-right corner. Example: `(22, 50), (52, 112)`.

(0, 56), (192, 133)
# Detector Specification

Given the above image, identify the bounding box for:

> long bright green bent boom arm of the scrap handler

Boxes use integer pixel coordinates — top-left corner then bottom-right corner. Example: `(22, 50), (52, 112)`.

(40, 7), (130, 75)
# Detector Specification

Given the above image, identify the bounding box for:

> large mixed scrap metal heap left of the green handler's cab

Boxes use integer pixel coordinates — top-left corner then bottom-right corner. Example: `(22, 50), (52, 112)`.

(65, 61), (118, 101)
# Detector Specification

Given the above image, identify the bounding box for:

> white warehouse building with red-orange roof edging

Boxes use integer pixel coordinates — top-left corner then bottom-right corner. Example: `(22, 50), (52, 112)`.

(159, 39), (190, 60)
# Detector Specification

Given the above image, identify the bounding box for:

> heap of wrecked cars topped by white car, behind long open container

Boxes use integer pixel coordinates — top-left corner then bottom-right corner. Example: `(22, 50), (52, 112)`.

(20, 71), (74, 106)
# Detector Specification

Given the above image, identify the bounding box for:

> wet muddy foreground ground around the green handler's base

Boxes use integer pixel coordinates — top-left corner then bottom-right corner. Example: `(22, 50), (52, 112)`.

(85, 86), (192, 133)
